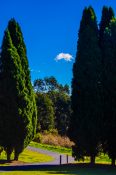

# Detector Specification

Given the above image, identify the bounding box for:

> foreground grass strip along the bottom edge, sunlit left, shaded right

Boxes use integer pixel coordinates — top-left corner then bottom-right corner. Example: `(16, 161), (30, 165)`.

(0, 165), (116, 175)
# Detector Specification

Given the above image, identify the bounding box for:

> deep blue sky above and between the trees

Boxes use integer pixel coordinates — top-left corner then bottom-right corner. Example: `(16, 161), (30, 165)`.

(0, 0), (116, 85)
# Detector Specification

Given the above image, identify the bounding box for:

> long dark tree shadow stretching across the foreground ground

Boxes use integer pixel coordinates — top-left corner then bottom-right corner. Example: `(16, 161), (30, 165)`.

(0, 163), (116, 175)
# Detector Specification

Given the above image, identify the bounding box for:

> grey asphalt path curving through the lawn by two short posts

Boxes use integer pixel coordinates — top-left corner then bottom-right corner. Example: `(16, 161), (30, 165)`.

(27, 146), (74, 165)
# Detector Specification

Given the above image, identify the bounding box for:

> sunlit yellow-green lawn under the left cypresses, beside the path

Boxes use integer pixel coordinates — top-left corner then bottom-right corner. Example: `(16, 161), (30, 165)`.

(0, 149), (54, 165)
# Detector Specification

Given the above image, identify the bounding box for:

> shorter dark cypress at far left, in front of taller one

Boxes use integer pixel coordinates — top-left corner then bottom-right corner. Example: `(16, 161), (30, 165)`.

(0, 30), (24, 160)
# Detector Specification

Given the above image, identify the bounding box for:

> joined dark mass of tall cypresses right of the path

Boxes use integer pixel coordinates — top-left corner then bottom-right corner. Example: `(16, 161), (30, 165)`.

(69, 6), (116, 165)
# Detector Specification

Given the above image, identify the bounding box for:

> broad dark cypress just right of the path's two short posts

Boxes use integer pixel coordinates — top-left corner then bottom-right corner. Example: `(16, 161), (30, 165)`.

(69, 7), (101, 163)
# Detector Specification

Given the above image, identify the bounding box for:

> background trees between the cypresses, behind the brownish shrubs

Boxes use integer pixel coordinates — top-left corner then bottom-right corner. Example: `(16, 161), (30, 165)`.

(34, 76), (71, 135)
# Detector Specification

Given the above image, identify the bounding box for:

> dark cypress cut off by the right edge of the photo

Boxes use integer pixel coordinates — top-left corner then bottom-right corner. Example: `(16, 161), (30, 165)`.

(99, 7), (116, 164)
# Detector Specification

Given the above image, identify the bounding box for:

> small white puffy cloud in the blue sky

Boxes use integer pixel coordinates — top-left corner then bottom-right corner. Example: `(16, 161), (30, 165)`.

(55, 53), (73, 61)
